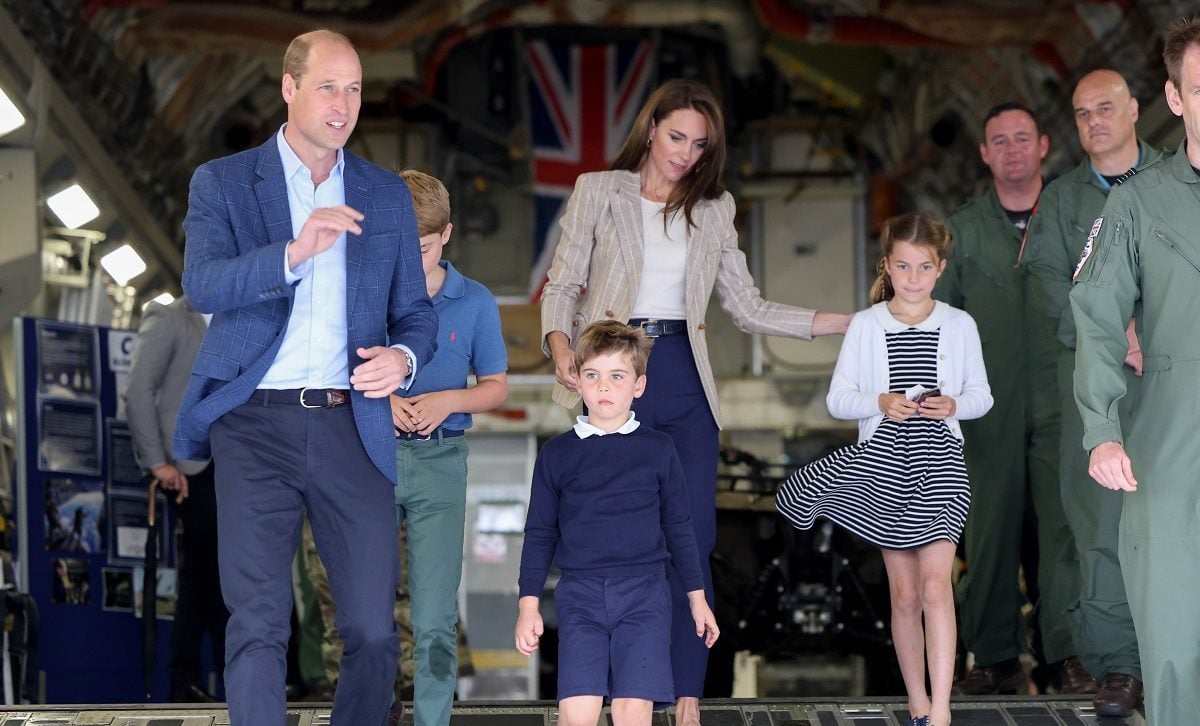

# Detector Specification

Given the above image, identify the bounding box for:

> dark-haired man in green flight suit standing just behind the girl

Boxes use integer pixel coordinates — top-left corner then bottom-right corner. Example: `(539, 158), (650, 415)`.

(934, 103), (1096, 695)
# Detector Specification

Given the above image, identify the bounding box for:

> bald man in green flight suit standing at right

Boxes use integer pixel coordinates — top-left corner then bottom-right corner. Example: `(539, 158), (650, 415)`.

(1021, 70), (1162, 716)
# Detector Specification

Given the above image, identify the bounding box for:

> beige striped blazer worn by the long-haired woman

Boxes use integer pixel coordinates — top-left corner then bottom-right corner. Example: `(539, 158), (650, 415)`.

(541, 172), (816, 426)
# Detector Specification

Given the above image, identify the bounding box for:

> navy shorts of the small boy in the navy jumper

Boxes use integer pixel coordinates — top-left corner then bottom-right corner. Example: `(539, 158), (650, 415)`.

(554, 572), (674, 704)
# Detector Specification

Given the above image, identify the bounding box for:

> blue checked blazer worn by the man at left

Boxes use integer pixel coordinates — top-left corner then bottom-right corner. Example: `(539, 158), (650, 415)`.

(173, 136), (438, 481)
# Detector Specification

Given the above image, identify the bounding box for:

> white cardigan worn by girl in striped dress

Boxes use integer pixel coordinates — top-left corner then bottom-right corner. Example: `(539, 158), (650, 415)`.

(826, 301), (992, 442)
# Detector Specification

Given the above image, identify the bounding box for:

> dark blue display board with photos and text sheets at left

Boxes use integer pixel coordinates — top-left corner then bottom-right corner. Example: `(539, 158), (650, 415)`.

(16, 318), (175, 703)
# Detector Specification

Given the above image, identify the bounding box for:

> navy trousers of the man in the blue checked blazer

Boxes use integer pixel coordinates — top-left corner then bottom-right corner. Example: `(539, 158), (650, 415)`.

(211, 400), (400, 726)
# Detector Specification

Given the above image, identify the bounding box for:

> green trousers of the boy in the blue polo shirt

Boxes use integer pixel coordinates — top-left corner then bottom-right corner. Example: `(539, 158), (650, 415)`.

(396, 436), (467, 726)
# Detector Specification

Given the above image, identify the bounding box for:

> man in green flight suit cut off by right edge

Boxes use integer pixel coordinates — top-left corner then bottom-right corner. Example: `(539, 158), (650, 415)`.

(1070, 19), (1200, 726)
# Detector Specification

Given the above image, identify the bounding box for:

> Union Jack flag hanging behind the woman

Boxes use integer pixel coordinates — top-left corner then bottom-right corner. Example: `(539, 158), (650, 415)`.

(526, 40), (654, 297)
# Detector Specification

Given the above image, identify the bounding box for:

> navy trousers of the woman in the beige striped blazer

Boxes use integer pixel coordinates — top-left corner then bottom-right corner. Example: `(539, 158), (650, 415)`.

(634, 335), (720, 698)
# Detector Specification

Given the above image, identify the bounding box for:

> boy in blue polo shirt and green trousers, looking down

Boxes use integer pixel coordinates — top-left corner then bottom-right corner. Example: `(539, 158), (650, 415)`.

(391, 169), (508, 726)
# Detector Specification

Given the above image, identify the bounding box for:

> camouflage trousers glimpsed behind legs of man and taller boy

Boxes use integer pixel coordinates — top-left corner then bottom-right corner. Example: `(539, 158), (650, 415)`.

(300, 520), (475, 686)
